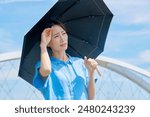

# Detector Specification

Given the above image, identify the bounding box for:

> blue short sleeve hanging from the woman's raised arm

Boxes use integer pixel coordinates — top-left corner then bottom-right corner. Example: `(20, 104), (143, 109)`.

(33, 62), (48, 91)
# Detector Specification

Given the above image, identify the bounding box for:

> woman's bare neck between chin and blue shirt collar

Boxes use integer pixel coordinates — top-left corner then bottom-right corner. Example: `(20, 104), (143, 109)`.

(52, 52), (68, 61)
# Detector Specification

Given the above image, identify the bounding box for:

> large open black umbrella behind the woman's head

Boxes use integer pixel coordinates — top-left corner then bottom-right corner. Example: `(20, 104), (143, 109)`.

(19, 0), (113, 84)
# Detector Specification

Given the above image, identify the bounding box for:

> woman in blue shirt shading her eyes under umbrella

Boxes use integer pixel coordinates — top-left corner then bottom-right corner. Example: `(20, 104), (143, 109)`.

(33, 21), (97, 100)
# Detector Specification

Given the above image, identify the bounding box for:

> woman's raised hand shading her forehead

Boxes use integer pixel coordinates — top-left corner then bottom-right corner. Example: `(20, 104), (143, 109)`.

(41, 28), (52, 47)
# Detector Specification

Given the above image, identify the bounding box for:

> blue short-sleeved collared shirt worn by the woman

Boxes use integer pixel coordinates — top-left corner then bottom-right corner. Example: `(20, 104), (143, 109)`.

(33, 56), (96, 100)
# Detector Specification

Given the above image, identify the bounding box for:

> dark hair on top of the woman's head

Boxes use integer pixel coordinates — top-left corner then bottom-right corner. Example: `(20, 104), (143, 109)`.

(46, 20), (66, 31)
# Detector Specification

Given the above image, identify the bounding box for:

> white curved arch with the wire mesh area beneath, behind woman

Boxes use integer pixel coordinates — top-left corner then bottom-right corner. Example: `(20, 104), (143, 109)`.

(0, 52), (150, 99)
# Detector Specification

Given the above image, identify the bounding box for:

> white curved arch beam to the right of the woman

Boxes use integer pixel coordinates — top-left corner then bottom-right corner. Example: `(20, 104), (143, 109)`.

(96, 56), (150, 93)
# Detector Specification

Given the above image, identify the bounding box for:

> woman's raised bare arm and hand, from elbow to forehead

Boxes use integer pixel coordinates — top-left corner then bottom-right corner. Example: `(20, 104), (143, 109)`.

(39, 28), (51, 80)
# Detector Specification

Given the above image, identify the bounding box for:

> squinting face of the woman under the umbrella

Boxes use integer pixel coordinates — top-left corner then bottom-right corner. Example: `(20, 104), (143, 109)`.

(49, 25), (68, 52)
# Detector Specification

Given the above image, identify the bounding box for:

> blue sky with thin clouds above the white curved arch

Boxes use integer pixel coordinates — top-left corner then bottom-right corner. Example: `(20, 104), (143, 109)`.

(0, 0), (150, 70)
